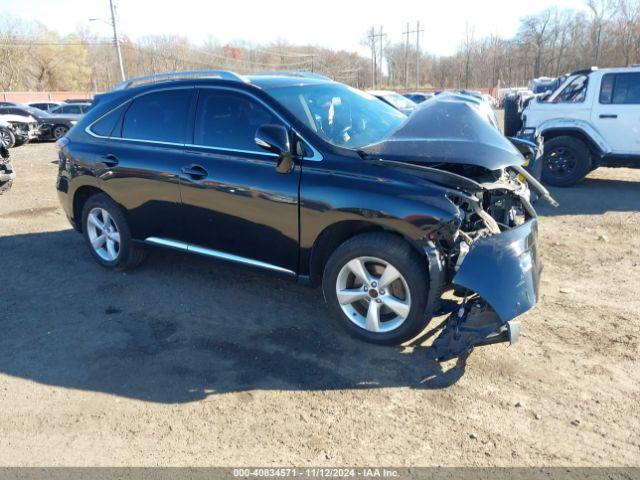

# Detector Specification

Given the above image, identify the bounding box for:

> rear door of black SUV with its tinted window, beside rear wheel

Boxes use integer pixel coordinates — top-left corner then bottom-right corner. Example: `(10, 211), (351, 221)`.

(90, 87), (194, 240)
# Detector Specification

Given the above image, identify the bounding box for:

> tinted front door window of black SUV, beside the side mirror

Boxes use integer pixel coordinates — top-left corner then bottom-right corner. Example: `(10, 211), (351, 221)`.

(193, 90), (282, 153)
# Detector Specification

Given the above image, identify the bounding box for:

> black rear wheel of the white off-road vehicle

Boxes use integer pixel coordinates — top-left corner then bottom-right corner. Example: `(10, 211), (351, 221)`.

(542, 136), (591, 187)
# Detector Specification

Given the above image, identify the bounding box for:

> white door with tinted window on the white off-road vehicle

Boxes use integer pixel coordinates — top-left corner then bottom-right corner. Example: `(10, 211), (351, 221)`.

(591, 72), (640, 155)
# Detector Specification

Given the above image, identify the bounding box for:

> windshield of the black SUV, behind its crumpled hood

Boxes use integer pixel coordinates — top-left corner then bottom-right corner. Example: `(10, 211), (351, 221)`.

(269, 83), (407, 150)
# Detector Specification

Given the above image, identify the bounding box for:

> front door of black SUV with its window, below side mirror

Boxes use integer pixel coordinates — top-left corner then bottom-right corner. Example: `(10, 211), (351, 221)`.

(180, 88), (300, 273)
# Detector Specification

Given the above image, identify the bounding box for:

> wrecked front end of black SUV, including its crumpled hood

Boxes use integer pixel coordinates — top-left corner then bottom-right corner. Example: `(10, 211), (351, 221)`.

(360, 99), (557, 360)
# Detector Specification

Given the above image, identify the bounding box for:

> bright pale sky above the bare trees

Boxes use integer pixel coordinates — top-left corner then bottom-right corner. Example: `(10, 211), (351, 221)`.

(0, 0), (584, 55)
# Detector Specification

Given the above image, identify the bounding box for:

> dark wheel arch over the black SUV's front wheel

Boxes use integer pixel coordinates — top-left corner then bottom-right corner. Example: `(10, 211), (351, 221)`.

(308, 220), (424, 285)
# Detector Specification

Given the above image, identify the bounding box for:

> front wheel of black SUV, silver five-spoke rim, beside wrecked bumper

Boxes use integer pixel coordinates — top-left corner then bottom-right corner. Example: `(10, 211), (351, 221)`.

(322, 233), (429, 345)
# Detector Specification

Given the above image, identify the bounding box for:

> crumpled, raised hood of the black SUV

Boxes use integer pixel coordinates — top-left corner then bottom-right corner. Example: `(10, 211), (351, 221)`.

(361, 97), (524, 170)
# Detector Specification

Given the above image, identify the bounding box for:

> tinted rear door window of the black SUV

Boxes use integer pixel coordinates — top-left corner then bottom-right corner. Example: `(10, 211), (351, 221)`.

(122, 89), (193, 143)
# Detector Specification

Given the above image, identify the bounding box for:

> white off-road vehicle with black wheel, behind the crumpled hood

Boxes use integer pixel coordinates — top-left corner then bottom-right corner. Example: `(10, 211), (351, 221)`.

(505, 66), (640, 186)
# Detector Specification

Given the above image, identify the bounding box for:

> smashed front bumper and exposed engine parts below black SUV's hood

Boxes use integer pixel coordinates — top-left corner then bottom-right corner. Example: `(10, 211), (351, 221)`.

(430, 168), (548, 361)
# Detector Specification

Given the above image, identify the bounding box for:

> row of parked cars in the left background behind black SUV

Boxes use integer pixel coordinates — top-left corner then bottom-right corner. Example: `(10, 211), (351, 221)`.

(0, 101), (91, 148)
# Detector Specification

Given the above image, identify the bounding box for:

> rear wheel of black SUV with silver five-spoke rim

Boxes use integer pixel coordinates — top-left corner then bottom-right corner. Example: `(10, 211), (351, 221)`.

(82, 193), (147, 270)
